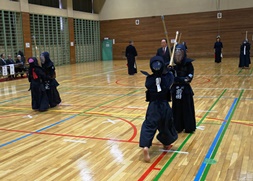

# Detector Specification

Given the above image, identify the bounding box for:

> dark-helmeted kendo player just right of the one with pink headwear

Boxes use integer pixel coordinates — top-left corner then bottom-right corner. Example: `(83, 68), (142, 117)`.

(40, 52), (61, 108)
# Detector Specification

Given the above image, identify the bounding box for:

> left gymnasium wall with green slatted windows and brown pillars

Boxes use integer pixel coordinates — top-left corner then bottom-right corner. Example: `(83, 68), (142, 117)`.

(0, 0), (102, 65)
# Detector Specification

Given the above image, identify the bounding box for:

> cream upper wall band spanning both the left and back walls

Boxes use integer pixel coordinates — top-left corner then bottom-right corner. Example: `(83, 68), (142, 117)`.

(0, 0), (253, 20)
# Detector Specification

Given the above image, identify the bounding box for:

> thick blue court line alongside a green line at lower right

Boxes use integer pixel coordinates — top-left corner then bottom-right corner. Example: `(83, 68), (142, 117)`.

(194, 98), (238, 181)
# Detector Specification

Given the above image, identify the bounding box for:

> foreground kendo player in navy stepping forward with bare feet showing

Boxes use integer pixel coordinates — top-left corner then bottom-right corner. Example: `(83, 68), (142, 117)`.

(139, 56), (178, 162)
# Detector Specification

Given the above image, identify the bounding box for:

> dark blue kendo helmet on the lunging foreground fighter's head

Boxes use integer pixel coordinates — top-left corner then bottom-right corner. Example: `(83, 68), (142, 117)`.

(150, 56), (165, 75)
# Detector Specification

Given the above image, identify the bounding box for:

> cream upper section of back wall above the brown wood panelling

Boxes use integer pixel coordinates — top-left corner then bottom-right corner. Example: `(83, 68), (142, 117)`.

(99, 0), (253, 20)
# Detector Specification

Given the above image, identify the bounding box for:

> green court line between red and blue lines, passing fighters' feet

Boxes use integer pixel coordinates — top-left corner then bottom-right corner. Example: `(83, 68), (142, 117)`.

(154, 89), (227, 181)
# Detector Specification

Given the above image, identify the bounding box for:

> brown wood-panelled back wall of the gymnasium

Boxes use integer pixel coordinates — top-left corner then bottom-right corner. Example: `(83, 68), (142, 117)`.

(99, 6), (253, 60)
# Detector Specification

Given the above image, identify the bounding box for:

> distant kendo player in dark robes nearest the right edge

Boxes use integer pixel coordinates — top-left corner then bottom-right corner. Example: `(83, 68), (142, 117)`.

(239, 40), (251, 68)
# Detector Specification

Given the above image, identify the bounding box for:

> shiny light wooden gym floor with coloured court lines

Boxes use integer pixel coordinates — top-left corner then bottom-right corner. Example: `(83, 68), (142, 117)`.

(0, 58), (253, 181)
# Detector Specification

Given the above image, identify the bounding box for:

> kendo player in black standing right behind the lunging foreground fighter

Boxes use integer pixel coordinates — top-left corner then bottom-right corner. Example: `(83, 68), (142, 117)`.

(171, 44), (196, 133)
